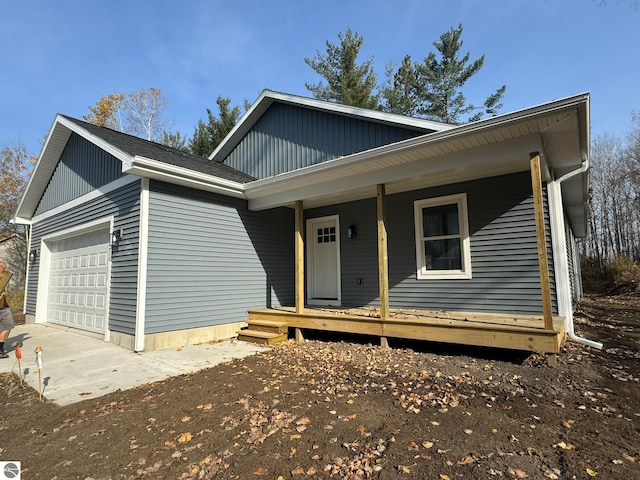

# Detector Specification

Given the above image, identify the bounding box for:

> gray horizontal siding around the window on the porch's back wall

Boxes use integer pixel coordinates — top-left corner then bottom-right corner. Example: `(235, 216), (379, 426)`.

(305, 173), (557, 314)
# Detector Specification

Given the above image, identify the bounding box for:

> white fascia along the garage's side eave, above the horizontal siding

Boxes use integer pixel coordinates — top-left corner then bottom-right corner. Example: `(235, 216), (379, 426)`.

(126, 155), (244, 198)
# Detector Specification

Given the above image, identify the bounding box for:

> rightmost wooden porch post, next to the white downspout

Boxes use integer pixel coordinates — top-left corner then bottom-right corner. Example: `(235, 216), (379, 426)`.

(529, 152), (553, 330)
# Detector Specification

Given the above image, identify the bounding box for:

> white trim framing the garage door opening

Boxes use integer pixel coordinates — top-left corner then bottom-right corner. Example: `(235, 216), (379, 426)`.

(35, 215), (114, 341)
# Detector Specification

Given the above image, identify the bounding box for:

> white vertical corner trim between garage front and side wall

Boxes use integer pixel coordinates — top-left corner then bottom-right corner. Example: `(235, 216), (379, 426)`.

(134, 178), (149, 352)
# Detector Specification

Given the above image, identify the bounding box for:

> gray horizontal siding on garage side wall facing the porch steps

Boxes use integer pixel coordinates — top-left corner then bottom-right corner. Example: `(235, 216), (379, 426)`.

(145, 181), (294, 334)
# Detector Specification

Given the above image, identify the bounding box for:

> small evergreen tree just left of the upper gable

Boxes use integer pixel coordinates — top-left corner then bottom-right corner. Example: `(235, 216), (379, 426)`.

(189, 96), (240, 157)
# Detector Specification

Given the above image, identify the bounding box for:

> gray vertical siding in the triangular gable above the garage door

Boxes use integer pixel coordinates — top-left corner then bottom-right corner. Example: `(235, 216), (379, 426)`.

(35, 133), (123, 215)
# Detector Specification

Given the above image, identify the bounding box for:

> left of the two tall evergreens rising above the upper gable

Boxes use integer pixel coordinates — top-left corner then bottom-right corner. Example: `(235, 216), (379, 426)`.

(304, 29), (378, 109)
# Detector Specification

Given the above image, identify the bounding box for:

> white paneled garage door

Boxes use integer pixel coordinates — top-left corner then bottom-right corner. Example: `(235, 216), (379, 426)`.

(47, 230), (109, 333)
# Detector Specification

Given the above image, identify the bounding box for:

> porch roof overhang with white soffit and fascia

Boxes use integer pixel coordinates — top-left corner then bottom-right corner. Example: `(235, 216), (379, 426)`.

(244, 94), (589, 236)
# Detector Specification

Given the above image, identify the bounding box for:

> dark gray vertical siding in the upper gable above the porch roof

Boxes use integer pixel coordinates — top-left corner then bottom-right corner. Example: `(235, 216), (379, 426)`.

(224, 103), (426, 178)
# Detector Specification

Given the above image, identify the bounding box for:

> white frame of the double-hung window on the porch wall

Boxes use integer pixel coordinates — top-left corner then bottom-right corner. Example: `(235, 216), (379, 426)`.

(413, 193), (471, 280)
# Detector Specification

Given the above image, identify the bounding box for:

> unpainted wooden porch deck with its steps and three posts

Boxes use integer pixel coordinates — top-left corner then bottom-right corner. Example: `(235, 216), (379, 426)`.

(241, 152), (566, 364)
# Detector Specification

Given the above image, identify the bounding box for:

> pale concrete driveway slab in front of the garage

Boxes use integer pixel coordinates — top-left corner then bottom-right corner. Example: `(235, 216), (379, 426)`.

(0, 324), (265, 405)
